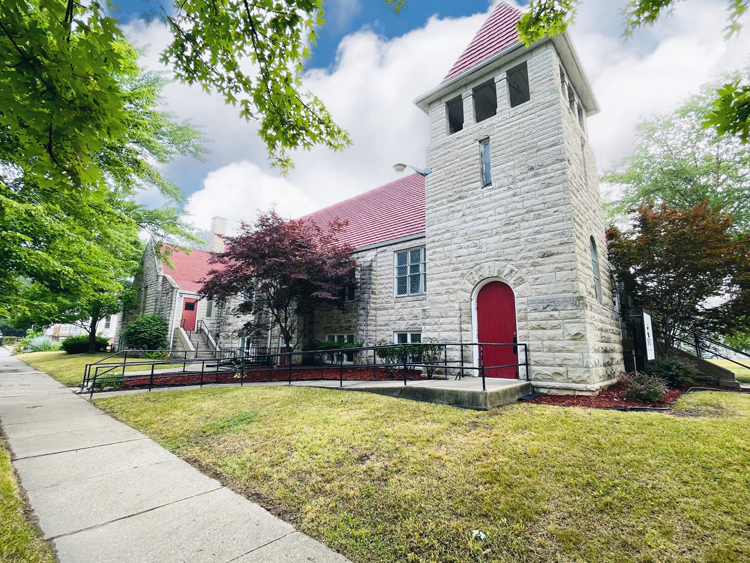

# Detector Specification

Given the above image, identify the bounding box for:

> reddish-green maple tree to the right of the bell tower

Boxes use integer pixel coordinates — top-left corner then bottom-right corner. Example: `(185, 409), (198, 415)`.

(607, 202), (750, 353)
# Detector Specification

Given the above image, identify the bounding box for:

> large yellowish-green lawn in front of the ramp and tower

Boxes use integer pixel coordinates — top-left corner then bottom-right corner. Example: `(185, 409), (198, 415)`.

(96, 387), (750, 563)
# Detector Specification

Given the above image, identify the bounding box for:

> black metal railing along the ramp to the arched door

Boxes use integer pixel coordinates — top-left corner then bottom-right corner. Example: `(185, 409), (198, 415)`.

(81, 342), (530, 395)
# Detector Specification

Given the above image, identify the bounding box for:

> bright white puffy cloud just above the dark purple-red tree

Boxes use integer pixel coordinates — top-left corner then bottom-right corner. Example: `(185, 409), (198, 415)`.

(186, 161), (315, 233)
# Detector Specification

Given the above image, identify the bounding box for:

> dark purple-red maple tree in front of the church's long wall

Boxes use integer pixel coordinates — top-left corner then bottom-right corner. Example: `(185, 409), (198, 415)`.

(200, 211), (357, 351)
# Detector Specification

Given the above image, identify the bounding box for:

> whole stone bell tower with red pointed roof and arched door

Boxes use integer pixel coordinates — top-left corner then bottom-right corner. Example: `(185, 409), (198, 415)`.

(417, 4), (623, 394)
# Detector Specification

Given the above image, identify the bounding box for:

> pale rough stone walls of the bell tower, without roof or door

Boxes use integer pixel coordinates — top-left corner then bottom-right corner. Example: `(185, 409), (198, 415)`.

(424, 43), (622, 392)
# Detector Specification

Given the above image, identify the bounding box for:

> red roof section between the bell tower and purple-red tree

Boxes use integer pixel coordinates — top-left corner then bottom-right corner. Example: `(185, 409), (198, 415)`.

(302, 174), (425, 248)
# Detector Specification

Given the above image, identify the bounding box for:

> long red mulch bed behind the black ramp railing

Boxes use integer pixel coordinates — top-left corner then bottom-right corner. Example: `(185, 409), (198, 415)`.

(122, 366), (422, 388)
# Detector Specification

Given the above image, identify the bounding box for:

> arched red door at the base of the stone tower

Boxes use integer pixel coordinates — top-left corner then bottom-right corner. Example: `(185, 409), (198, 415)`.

(477, 282), (518, 379)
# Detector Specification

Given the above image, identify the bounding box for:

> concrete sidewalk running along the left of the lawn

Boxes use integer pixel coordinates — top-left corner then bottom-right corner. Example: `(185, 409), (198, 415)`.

(0, 348), (347, 563)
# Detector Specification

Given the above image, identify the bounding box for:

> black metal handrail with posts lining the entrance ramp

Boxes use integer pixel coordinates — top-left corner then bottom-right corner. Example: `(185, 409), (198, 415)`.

(81, 342), (530, 394)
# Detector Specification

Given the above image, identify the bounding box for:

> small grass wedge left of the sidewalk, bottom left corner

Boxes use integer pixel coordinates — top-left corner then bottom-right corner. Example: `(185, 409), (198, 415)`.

(0, 437), (55, 563)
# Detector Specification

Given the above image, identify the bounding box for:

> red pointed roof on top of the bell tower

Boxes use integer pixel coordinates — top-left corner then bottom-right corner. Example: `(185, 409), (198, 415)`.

(445, 3), (521, 80)
